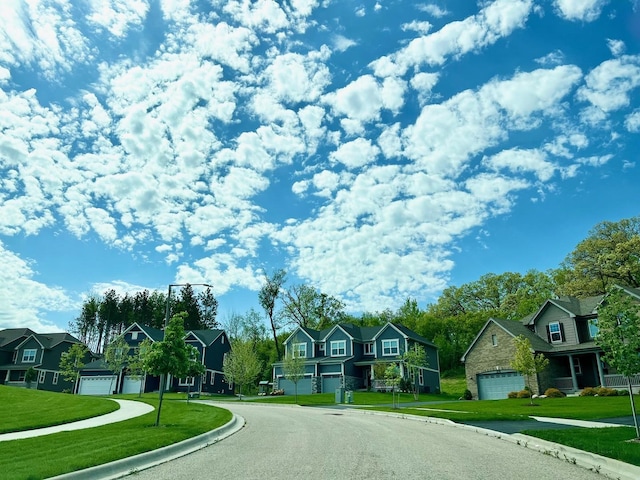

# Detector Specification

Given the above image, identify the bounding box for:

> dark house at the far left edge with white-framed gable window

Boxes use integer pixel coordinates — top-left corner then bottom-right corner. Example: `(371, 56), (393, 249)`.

(0, 328), (89, 392)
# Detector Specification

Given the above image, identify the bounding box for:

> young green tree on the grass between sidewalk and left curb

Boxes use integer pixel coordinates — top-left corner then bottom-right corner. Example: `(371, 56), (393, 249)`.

(145, 312), (200, 427)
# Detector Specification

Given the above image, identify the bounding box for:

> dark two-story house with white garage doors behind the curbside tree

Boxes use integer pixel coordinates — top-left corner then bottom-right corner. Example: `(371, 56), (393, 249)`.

(78, 323), (232, 395)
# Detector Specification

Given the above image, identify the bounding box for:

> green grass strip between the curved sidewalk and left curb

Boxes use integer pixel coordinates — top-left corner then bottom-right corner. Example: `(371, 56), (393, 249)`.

(0, 387), (232, 480)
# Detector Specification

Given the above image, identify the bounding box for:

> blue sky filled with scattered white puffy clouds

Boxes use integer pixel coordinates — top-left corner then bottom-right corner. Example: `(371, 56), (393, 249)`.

(0, 0), (640, 331)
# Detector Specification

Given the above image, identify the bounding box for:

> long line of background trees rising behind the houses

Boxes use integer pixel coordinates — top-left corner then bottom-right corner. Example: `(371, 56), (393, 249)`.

(72, 217), (640, 379)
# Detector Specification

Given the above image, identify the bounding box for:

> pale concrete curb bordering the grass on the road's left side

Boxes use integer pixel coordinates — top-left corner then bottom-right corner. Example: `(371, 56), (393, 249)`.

(51, 415), (245, 480)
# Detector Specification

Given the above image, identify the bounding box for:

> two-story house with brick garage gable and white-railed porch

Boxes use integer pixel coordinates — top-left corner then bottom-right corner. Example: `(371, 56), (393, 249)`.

(462, 288), (640, 400)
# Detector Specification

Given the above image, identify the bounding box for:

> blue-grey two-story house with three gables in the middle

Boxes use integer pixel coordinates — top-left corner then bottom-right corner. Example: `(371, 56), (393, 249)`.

(273, 323), (440, 394)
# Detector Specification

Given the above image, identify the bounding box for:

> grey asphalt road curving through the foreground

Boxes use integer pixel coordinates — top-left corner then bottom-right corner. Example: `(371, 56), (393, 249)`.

(127, 403), (603, 480)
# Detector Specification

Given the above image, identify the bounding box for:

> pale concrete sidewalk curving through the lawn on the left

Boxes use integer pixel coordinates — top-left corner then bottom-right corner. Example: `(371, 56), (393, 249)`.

(0, 398), (154, 442)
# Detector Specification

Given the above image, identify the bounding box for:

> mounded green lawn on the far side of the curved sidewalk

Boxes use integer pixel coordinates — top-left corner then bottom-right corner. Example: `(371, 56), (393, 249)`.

(0, 385), (120, 433)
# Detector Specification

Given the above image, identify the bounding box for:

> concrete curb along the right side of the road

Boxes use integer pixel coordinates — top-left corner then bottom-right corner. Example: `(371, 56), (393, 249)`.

(350, 410), (640, 480)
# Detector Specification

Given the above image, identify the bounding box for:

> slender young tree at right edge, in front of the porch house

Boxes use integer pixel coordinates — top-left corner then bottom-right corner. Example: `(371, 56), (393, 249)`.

(596, 287), (640, 438)
